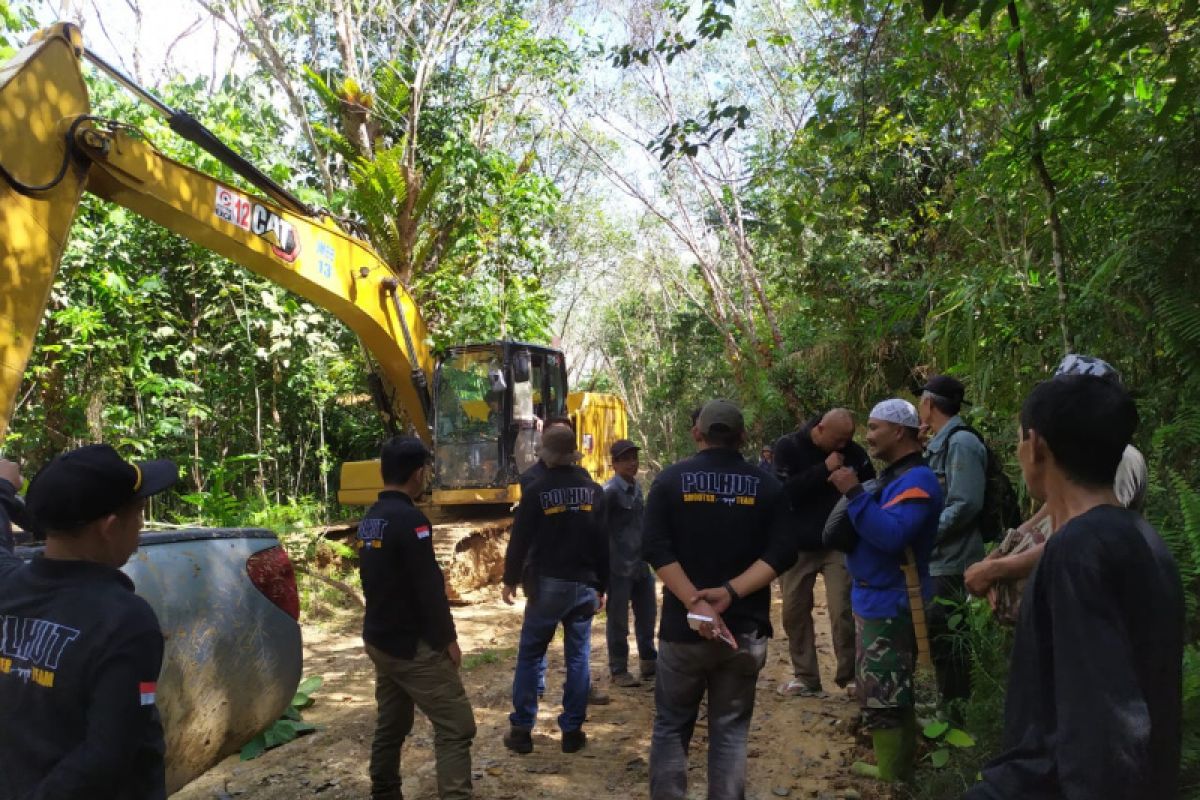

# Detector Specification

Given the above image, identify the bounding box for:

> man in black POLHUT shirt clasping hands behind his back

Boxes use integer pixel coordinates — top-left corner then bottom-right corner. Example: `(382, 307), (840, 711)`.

(642, 401), (796, 800)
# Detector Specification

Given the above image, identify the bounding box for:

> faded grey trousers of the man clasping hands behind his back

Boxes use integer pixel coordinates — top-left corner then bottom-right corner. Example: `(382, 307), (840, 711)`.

(650, 636), (767, 800)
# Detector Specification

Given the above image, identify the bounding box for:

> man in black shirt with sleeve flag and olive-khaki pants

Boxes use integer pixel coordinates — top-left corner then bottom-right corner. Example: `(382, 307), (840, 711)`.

(355, 437), (475, 800)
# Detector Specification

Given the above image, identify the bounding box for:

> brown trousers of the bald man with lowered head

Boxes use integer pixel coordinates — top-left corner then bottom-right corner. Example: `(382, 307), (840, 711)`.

(779, 551), (854, 687)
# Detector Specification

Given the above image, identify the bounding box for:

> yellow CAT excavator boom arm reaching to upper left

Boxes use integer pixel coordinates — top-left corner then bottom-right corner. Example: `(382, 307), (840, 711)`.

(0, 24), (433, 443)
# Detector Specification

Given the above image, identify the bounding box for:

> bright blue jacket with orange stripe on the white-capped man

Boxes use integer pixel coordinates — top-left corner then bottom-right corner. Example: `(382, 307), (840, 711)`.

(846, 453), (942, 619)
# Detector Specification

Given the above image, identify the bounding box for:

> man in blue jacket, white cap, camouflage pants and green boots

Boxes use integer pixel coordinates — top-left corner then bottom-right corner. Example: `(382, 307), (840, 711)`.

(829, 398), (942, 782)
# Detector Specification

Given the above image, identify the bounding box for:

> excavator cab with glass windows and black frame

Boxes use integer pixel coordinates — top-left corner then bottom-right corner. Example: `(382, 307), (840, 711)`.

(432, 342), (566, 505)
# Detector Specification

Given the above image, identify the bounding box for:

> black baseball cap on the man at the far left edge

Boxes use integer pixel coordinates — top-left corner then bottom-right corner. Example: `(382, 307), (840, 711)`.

(25, 445), (179, 533)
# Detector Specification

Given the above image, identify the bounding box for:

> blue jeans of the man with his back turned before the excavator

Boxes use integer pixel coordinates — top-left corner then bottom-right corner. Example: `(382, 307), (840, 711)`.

(509, 578), (599, 732)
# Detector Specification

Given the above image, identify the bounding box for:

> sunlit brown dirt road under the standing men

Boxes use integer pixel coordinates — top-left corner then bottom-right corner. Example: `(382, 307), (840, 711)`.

(173, 583), (887, 800)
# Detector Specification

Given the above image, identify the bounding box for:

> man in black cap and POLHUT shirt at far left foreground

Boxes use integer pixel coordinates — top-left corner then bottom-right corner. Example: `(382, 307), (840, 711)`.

(0, 445), (179, 800)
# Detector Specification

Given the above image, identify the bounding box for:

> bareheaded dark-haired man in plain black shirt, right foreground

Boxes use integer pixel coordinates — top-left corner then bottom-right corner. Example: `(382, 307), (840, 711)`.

(966, 375), (1184, 800)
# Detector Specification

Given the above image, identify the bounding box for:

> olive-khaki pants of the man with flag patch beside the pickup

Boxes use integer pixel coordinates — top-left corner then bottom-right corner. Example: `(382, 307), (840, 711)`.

(366, 642), (475, 800)
